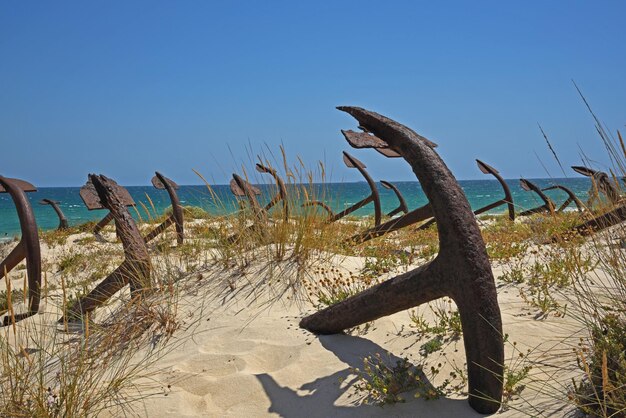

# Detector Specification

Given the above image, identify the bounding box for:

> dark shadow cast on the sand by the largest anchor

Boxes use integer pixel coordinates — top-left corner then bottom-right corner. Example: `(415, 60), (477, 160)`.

(256, 334), (483, 418)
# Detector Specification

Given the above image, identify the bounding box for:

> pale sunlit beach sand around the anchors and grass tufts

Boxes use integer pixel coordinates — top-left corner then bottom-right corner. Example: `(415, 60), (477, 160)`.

(2, 212), (604, 417)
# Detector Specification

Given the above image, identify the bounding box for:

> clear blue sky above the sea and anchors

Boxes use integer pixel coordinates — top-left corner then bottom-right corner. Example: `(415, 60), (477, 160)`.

(0, 0), (626, 186)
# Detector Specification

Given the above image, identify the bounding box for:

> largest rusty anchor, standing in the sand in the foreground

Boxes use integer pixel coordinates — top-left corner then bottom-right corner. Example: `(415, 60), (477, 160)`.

(300, 107), (504, 413)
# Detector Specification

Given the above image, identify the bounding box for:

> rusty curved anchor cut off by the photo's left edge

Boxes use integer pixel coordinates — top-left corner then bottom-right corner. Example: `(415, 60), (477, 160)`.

(0, 176), (41, 326)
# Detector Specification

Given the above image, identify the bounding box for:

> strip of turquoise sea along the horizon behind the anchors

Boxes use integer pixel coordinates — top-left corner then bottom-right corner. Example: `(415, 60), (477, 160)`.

(0, 177), (591, 240)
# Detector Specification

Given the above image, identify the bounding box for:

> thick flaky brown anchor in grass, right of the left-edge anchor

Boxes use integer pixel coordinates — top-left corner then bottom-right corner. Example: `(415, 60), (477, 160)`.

(59, 174), (152, 323)
